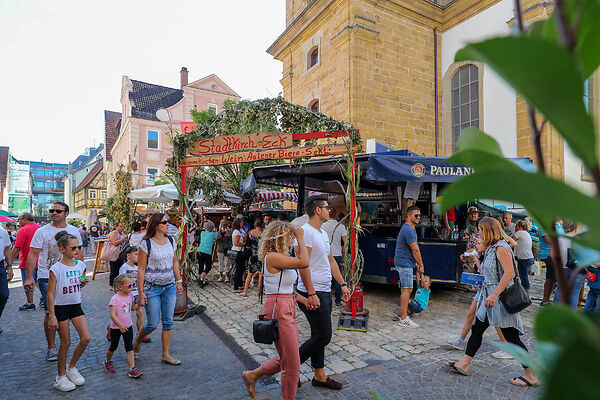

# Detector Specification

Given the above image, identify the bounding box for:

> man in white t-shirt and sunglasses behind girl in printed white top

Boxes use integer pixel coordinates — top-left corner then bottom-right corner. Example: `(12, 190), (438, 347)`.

(23, 201), (83, 361)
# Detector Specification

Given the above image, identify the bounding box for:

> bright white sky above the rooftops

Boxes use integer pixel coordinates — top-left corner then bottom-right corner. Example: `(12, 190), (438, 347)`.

(0, 0), (285, 163)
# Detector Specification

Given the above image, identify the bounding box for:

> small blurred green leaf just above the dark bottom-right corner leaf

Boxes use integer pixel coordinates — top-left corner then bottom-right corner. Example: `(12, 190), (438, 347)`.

(533, 305), (600, 346)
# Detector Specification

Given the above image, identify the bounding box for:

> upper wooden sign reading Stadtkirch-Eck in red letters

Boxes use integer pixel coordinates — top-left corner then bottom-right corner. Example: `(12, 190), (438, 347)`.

(190, 132), (292, 155)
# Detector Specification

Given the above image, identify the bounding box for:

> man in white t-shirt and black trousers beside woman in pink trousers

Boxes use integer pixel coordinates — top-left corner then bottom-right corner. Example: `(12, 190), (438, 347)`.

(296, 195), (350, 390)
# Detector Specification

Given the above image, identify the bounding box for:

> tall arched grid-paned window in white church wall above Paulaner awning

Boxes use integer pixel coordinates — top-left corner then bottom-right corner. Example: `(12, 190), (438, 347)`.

(450, 64), (479, 152)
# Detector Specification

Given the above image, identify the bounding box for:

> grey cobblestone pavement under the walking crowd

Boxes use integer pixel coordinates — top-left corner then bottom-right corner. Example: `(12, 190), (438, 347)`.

(0, 258), (539, 400)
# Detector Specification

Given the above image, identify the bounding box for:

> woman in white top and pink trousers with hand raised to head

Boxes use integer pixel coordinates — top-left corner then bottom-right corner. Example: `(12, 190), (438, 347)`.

(242, 221), (309, 400)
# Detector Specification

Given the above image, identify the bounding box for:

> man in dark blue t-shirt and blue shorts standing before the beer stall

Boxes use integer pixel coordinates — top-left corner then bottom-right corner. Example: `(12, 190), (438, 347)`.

(394, 206), (425, 328)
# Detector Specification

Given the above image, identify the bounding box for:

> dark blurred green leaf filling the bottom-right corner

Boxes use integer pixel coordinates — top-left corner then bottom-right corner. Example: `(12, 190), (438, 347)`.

(542, 336), (600, 400)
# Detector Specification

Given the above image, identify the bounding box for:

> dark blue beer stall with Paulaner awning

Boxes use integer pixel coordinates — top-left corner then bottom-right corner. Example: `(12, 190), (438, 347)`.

(253, 150), (471, 284)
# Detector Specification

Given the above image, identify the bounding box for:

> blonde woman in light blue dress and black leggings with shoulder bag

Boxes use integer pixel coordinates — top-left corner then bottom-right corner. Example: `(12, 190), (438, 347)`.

(445, 217), (539, 387)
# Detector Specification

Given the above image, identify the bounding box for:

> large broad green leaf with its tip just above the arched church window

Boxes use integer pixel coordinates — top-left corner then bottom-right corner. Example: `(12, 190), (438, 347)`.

(456, 36), (596, 167)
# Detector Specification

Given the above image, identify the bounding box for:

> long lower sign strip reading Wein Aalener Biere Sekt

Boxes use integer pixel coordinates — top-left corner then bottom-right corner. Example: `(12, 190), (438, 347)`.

(180, 144), (348, 168)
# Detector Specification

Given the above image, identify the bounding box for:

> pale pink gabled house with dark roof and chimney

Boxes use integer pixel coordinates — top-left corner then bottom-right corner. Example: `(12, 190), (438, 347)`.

(105, 67), (240, 195)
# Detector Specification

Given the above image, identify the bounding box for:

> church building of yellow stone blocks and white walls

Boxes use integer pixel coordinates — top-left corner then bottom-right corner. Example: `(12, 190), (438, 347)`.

(267, 0), (600, 190)
